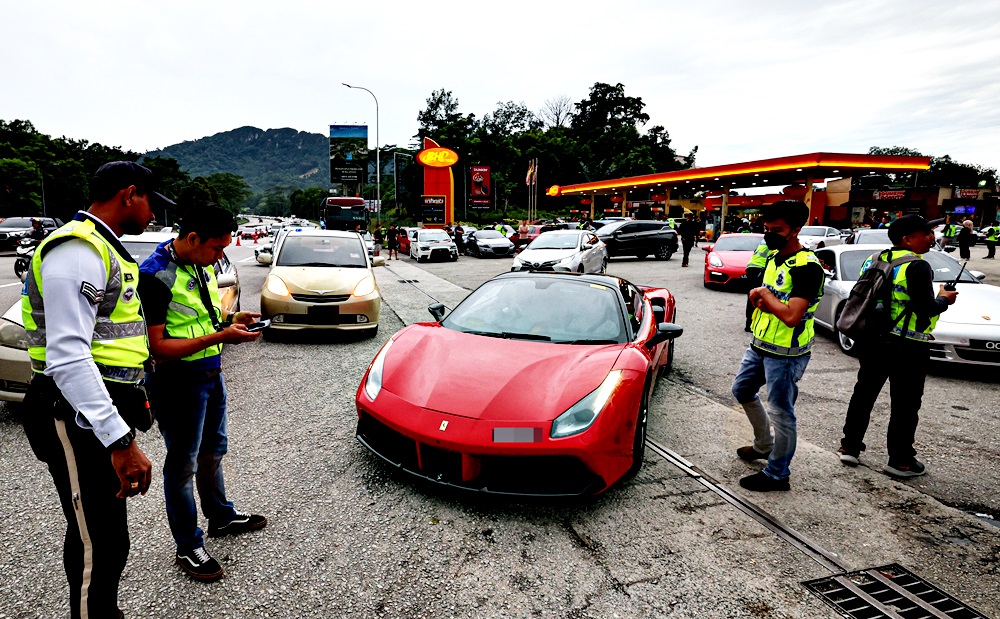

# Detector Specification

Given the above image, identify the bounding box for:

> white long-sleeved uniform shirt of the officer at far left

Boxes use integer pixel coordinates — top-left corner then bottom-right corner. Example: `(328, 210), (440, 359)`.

(36, 212), (129, 446)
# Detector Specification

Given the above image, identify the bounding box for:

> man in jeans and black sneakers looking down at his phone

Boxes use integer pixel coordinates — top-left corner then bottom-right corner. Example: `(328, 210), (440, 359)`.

(139, 202), (267, 582)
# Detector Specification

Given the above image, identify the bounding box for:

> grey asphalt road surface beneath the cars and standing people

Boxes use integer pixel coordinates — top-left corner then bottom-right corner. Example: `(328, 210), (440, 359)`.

(0, 239), (1000, 619)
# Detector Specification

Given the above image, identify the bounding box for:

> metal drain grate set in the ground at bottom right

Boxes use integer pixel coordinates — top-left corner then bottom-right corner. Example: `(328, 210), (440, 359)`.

(802, 563), (987, 619)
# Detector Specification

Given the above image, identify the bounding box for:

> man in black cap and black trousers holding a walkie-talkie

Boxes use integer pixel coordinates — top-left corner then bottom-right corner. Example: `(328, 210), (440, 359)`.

(839, 215), (958, 478)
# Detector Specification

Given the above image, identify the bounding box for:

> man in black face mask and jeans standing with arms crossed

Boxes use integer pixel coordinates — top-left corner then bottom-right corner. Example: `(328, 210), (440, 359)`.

(732, 200), (824, 492)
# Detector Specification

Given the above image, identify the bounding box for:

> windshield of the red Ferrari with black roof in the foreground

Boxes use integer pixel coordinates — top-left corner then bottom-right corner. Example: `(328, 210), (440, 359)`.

(441, 276), (627, 344)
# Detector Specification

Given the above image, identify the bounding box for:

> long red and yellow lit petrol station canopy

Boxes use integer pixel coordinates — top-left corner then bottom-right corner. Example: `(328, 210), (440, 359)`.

(546, 153), (930, 199)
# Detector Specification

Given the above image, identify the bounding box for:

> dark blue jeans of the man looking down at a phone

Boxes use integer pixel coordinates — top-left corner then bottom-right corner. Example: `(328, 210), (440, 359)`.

(147, 372), (236, 552)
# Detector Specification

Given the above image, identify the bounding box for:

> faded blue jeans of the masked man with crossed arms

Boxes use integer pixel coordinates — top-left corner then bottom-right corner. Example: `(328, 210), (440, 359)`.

(733, 348), (810, 480)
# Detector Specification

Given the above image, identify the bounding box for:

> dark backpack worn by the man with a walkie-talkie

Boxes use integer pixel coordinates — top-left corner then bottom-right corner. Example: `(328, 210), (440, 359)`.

(837, 250), (920, 342)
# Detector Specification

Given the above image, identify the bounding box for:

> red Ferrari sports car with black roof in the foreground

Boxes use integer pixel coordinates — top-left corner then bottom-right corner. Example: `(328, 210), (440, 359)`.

(356, 272), (683, 496)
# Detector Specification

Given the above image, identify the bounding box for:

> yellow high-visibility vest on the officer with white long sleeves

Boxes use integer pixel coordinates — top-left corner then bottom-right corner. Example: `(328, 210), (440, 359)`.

(21, 219), (149, 382)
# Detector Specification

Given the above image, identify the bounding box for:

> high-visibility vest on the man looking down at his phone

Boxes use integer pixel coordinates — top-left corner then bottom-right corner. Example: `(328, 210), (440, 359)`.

(148, 243), (222, 361)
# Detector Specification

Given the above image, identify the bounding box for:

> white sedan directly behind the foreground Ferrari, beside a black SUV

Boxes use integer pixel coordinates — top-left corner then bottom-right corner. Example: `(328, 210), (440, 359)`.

(510, 230), (608, 273)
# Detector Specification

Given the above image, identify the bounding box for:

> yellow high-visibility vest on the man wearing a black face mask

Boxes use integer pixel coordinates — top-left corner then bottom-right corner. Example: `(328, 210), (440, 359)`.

(752, 249), (824, 357)
